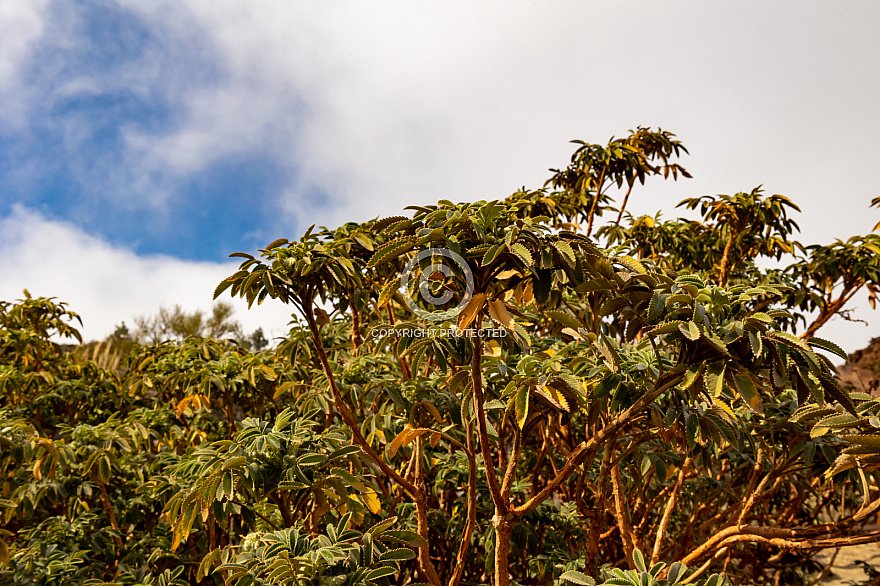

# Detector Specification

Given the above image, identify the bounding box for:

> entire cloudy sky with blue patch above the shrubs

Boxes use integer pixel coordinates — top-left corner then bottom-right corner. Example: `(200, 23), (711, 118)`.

(0, 0), (880, 351)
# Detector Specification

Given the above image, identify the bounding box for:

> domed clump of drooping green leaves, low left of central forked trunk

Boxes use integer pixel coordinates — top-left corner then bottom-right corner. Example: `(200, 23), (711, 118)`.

(165, 409), (378, 549)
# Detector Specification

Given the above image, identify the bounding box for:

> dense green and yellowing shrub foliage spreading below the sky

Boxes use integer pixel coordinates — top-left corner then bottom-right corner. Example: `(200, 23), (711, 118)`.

(0, 128), (880, 586)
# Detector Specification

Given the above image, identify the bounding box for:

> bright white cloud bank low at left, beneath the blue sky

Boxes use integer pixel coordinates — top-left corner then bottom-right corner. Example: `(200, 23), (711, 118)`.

(0, 206), (290, 340)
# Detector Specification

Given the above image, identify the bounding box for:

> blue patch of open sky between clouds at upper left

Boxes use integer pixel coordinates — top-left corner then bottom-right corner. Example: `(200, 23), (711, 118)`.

(0, 2), (295, 261)
